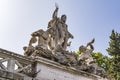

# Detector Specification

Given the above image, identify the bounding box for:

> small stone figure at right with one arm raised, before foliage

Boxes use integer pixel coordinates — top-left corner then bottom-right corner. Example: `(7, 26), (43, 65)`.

(79, 39), (94, 65)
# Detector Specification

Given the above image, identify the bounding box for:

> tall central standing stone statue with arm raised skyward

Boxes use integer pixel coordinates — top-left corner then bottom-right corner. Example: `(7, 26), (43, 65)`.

(48, 5), (73, 50)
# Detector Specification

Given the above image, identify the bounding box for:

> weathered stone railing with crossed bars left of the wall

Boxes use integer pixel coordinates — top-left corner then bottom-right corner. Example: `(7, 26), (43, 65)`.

(0, 49), (33, 80)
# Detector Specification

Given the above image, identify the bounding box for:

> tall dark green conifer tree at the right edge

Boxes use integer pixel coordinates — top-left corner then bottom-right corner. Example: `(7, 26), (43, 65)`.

(107, 30), (120, 80)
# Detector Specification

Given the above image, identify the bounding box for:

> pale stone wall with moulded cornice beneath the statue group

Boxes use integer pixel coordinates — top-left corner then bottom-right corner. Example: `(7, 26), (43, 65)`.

(36, 57), (105, 80)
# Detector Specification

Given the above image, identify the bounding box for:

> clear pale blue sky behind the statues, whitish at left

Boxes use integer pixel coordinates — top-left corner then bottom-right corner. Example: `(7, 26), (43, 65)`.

(0, 0), (120, 55)
